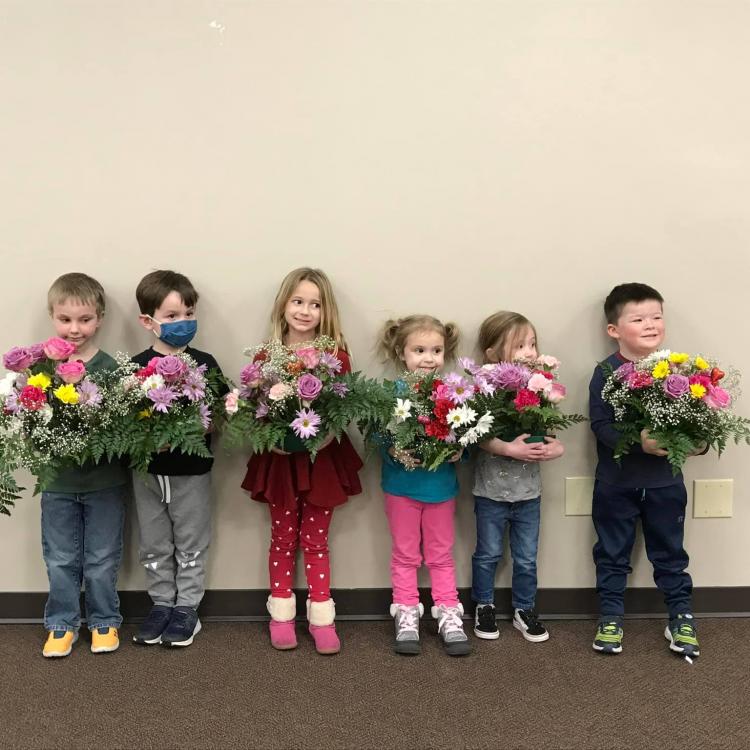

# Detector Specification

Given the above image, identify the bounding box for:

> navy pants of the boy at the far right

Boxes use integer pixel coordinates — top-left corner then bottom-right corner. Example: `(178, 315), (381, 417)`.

(591, 480), (693, 619)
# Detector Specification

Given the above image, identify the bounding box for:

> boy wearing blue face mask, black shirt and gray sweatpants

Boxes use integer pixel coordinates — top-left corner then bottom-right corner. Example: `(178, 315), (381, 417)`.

(133, 271), (226, 646)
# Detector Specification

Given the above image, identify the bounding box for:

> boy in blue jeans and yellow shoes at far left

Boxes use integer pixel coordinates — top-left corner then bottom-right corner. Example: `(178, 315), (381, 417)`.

(39, 273), (129, 657)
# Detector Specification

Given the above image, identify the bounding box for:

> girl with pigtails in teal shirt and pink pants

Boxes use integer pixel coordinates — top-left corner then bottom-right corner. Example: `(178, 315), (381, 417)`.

(379, 315), (472, 656)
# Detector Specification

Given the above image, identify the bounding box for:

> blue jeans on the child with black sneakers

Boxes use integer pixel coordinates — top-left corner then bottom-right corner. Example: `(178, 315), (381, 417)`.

(471, 496), (541, 609)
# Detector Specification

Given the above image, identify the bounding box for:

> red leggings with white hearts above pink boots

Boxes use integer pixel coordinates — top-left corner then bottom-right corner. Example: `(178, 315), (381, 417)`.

(268, 500), (333, 602)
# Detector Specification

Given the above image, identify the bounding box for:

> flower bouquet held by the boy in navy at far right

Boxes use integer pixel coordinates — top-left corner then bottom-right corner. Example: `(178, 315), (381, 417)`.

(602, 349), (750, 475)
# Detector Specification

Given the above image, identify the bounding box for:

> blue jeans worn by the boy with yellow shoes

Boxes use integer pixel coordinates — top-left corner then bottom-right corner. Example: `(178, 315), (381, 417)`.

(42, 485), (126, 632)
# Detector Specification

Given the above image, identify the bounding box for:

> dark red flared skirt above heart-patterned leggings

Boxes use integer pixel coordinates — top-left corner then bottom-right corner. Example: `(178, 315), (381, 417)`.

(242, 434), (363, 510)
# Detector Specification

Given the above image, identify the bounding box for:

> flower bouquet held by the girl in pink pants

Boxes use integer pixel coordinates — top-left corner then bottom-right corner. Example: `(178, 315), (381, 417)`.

(369, 372), (494, 471)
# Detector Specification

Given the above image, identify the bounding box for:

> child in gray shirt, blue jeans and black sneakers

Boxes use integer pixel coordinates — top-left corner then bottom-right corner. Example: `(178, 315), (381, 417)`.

(471, 311), (563, 643)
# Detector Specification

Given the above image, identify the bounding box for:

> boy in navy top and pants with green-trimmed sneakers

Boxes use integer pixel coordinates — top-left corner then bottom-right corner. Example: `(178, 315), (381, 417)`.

(589, 283), (700, 657)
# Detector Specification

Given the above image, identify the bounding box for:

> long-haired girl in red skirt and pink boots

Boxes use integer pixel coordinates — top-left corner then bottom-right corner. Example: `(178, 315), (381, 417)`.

(242, 268), (362, 654)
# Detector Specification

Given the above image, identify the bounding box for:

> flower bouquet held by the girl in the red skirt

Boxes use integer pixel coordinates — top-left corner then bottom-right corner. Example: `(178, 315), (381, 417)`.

(224, 336), (388, 459)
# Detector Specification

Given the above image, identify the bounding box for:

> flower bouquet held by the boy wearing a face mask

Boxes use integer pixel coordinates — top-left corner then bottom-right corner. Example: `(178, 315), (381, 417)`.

(106, 352), (219, 472)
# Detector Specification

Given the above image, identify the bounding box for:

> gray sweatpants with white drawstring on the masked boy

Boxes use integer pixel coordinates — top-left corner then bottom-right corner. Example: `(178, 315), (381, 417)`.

(133, 472), (211, 609)
